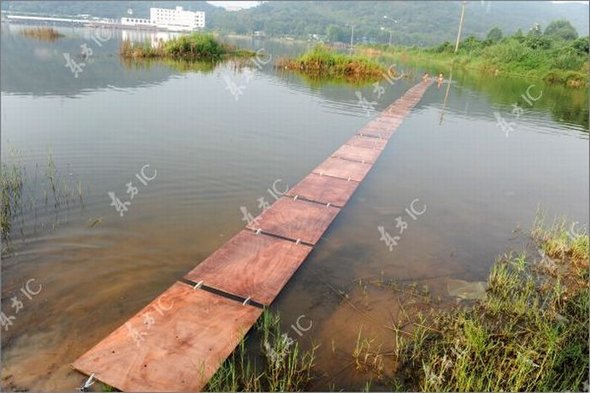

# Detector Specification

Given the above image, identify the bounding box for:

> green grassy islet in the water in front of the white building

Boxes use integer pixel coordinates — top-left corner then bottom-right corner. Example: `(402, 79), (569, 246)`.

(119, 33), (254, 61)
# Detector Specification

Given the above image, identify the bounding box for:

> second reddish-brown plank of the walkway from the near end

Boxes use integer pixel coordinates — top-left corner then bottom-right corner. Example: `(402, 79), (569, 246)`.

(184, 230), (311, 305)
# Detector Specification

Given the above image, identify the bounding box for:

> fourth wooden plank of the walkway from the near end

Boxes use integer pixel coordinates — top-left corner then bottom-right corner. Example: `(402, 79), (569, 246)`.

(285, 172), (360, 207)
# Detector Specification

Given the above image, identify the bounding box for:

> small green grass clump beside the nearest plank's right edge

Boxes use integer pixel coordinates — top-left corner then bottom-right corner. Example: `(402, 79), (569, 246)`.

(206, 311), (315, 392)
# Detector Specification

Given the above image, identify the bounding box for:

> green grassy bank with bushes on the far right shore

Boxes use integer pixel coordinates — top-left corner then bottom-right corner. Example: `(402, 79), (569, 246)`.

(357, 21), (590, 88)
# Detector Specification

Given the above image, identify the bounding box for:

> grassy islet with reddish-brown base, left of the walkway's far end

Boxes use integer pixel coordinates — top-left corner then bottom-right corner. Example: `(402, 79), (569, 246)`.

(277, 45), (386, 82)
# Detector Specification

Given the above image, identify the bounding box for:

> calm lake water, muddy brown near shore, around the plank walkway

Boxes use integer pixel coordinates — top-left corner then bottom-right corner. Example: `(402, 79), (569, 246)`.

(1, 24), (589, 391)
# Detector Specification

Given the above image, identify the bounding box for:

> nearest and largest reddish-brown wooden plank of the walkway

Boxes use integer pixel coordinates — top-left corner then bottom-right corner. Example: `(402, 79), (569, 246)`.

(73, 283), (262, 392)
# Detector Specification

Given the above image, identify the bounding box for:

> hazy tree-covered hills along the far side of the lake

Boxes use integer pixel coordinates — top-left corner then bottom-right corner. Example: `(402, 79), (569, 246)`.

(1, 0), (589, 45)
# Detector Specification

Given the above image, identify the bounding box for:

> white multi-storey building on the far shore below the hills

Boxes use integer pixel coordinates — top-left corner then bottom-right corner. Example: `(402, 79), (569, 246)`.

(121, 7), (205, 31)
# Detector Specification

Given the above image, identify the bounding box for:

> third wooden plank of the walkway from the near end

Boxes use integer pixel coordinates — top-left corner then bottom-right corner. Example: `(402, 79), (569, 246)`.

(247, 196), (340, 245)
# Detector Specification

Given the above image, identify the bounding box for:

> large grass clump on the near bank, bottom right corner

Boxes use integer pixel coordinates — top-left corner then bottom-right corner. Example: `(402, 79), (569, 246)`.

(396, 216), (590, 391)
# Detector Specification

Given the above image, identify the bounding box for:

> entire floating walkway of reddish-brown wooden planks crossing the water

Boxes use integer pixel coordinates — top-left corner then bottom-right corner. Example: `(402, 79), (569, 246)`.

(73, 82), (431, 392)
